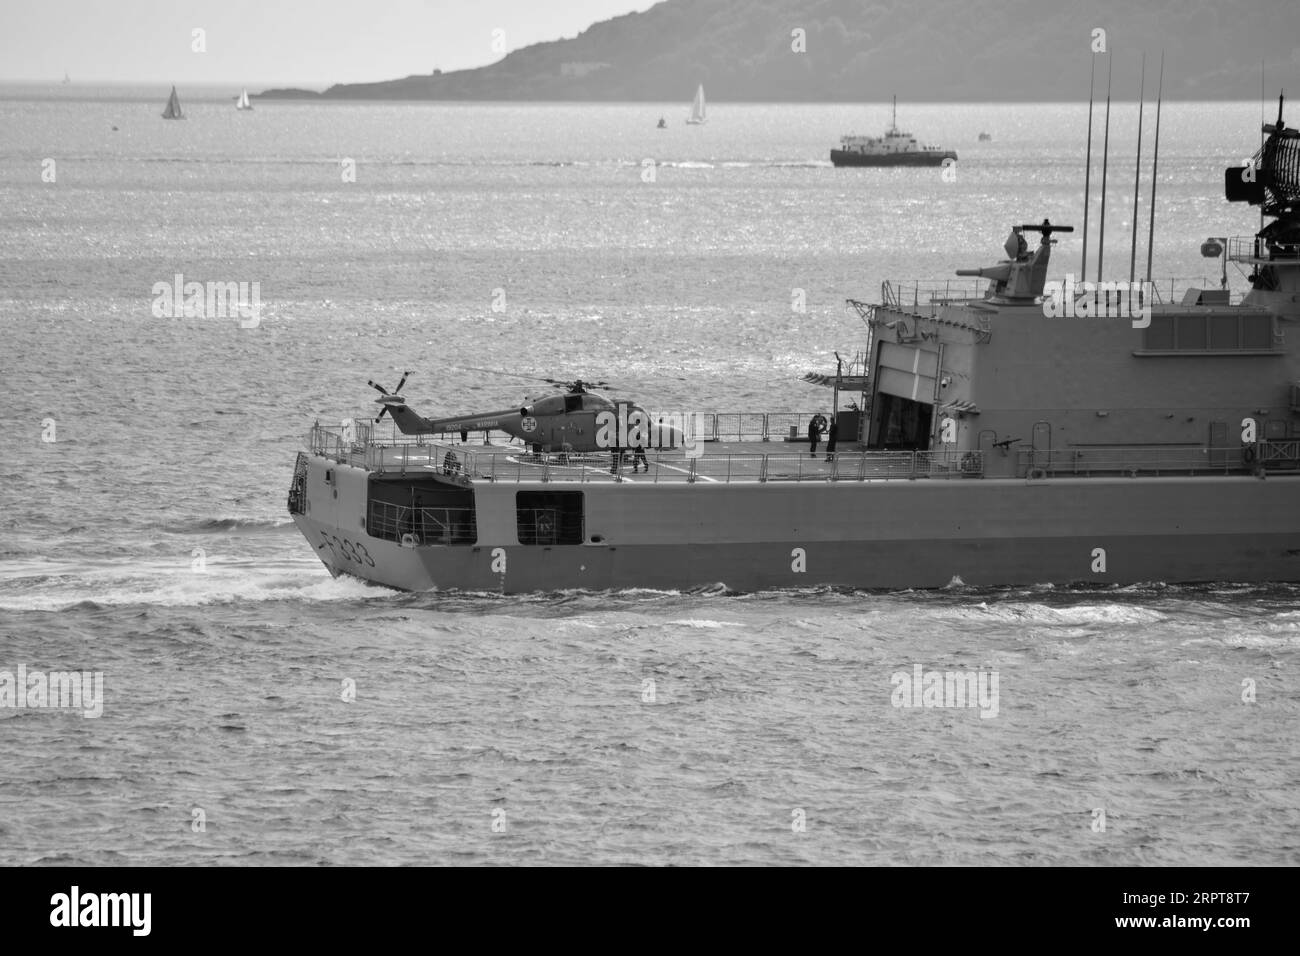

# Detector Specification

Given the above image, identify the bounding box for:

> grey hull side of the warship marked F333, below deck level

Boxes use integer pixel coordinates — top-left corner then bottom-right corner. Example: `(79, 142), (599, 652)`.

(294, 458), (1300, 593)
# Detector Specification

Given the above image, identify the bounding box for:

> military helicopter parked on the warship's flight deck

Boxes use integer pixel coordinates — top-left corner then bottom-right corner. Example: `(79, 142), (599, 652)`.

(367, 369), (688, 454)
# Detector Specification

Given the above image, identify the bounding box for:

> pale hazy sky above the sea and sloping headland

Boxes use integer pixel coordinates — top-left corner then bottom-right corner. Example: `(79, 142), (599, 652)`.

(0, 0), (655, 87)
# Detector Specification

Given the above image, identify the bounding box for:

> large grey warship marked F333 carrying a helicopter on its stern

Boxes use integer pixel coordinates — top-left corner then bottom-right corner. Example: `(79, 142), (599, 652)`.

(289, 101), (1300, 593)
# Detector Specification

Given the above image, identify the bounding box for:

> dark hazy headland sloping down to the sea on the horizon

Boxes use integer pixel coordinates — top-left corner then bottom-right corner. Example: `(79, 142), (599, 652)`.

(260, 0), (1300, 103)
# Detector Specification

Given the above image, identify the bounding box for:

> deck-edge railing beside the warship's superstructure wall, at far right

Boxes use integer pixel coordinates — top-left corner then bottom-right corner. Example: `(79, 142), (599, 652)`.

(1017, 447), (1284, 479)
